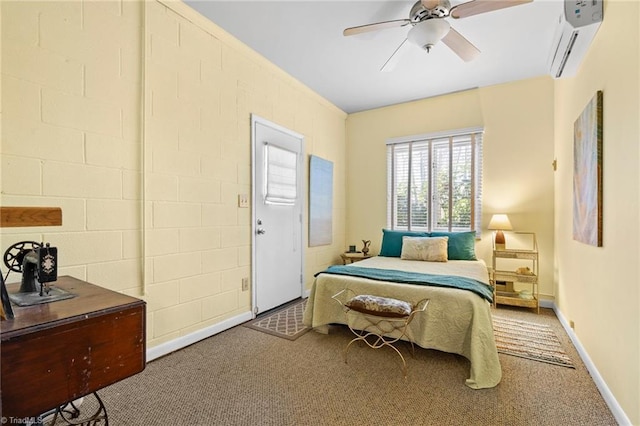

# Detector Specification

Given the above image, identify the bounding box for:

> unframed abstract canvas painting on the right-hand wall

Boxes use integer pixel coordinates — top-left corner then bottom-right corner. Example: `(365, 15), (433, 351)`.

(573, 91), (603, 247)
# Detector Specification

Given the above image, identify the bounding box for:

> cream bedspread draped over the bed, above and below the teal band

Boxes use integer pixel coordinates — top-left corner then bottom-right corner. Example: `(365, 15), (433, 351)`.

(303, 257), (502, 389)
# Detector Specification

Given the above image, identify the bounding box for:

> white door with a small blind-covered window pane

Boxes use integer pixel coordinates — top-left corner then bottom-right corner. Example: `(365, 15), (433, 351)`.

(251, 115), (304, 314)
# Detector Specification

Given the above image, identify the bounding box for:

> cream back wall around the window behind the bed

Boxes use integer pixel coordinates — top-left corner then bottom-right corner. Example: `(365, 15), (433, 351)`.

(347, 77), (554, 298)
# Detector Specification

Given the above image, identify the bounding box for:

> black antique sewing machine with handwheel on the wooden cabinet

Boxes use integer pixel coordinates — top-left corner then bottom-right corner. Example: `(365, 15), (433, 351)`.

(4, 241), (75, 306)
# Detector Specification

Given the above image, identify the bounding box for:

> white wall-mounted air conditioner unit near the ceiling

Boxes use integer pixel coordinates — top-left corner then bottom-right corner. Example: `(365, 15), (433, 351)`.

(549, 0), (603, 78)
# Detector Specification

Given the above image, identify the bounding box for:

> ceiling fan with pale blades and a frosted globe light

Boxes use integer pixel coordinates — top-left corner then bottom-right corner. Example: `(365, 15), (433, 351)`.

(343, 0), (533, 71)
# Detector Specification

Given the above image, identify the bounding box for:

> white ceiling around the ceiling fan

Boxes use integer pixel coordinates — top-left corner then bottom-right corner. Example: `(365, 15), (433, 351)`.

(185, 0), (563, 113)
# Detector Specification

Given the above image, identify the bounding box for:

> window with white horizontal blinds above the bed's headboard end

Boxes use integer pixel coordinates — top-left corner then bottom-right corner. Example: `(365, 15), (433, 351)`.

(387, 129), (483, 235)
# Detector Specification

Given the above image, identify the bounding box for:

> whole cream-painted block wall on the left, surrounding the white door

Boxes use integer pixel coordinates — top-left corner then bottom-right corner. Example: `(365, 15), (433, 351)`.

(0, 1), (346, 347)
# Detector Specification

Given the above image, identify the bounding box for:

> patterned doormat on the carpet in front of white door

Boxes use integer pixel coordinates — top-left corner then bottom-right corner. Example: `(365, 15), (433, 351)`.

(244, 299), (309, 340)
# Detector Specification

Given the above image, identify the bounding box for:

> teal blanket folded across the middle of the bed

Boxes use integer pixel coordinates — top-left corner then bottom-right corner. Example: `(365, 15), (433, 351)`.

(315, 265), (493, 302)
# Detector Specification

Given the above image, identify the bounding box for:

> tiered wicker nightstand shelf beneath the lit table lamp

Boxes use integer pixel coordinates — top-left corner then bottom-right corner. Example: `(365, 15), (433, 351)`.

(491, 232), (540, 313)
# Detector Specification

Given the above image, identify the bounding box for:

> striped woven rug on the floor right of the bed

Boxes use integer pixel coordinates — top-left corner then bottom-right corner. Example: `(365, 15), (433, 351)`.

(493, 316), (575, 368)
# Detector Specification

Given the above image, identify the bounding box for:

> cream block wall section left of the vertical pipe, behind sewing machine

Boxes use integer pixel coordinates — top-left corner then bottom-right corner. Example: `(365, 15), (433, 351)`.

(0, 1), (143, 300)
